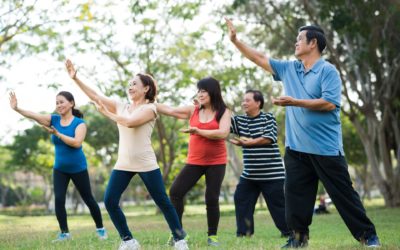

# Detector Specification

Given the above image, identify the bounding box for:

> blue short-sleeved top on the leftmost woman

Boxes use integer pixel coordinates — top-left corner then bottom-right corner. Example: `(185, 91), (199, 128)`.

(51, 114), (87, 173)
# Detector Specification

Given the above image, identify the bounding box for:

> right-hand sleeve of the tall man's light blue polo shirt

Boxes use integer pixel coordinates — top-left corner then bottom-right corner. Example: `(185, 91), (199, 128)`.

(321, 66), (342, 108)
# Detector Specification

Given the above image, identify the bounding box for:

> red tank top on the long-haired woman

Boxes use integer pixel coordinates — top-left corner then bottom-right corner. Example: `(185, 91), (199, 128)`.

(186, 106), (227, 166)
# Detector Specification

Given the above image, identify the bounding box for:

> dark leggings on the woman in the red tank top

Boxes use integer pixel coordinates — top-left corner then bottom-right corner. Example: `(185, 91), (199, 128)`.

(169, 164), (225, 235)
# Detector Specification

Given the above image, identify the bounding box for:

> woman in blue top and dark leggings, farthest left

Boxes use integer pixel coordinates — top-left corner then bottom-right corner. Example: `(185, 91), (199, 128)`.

(10, 91), (107, 241)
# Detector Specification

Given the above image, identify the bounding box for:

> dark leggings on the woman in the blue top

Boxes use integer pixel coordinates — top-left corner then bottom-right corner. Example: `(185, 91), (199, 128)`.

(53, 169), (103, 233)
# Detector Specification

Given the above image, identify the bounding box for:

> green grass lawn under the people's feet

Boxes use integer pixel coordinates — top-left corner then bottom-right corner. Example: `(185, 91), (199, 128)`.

(0, 204), (400, 250)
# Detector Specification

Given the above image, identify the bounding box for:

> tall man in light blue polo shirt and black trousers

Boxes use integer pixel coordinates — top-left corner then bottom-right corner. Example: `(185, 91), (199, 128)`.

(226, 19), (380, 248)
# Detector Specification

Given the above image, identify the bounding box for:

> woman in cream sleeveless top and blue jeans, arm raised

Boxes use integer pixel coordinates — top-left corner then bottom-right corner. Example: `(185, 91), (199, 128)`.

(66, 60), (188, 250)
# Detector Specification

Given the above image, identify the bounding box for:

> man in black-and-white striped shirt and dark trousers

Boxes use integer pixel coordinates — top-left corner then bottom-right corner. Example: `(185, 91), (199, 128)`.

(230, 90), (290, 237)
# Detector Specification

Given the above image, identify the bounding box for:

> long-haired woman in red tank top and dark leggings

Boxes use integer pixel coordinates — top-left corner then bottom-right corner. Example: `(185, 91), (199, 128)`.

(156, 77), (231, 246)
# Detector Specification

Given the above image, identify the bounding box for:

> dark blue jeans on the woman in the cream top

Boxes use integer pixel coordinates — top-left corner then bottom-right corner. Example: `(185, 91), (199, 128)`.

(104, 169), (185, 240)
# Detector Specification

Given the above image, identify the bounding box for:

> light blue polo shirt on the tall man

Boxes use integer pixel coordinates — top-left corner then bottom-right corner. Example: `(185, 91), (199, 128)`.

(269, 58), (344, 156)
